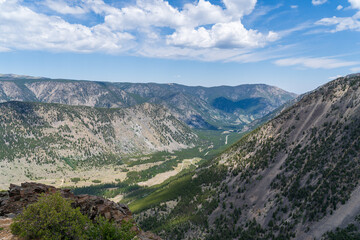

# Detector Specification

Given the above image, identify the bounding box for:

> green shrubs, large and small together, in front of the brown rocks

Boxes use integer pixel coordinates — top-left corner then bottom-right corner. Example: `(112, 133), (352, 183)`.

(10, 193), (136, 240)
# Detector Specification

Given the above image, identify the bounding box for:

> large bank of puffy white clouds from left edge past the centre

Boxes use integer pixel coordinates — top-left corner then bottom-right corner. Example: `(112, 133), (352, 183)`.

(0, 0), (280, 58)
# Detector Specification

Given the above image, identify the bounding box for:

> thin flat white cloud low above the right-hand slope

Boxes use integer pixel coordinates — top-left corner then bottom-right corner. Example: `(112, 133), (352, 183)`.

(274, 57), (359, 69)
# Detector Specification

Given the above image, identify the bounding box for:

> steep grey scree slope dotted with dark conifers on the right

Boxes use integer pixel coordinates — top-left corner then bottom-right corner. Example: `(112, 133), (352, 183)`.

(131, 75), (360, 239)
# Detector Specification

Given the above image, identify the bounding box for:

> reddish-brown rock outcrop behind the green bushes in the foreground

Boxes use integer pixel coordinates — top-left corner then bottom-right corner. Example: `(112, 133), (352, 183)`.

(0, 182), (160, 240)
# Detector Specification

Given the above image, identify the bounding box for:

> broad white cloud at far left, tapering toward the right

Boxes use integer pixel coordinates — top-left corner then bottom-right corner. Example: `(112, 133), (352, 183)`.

(0, 0), (133, 52)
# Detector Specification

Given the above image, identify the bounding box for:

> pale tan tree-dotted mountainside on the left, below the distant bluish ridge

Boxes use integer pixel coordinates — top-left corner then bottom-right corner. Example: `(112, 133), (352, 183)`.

(0, 102), (198, 189)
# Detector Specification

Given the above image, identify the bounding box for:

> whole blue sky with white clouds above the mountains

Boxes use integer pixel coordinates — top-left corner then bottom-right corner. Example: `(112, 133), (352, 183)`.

(0, 0), (360, 93)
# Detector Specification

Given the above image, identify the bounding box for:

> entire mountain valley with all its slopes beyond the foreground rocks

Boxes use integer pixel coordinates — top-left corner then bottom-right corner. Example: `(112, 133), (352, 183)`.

(0, 75), (360, 240)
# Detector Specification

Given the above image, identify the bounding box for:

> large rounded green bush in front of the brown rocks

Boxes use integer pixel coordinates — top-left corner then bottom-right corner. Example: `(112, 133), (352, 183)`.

(10, 193), (91, 240)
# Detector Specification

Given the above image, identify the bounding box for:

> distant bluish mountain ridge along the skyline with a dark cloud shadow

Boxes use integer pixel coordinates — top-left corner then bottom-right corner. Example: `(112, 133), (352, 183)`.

(0, 75), (296, 129)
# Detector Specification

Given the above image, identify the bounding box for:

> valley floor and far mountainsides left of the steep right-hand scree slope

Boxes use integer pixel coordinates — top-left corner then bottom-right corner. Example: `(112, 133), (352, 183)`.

(0, 75), (295, 189)
